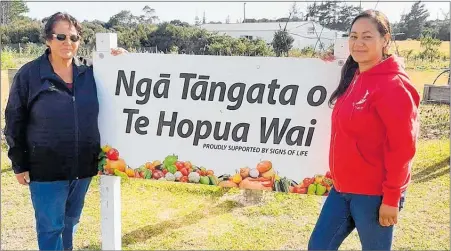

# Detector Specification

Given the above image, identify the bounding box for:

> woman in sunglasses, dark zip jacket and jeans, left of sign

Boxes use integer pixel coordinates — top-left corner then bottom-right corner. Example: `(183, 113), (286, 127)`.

(5, 12), (123, 250)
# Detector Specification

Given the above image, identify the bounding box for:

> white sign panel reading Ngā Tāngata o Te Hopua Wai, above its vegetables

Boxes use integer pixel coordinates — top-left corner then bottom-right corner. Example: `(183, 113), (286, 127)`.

(94, 52), (340, 181)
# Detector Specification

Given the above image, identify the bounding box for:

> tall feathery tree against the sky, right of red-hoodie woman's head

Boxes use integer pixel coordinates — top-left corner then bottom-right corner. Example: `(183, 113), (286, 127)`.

(399, 2), (429, 39)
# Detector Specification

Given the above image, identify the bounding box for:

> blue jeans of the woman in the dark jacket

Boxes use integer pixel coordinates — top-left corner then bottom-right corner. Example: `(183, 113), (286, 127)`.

(30, 178), (92, 250)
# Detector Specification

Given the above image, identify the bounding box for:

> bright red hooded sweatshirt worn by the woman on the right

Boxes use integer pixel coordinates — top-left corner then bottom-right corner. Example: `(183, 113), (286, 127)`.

(329, 56), (420, 207)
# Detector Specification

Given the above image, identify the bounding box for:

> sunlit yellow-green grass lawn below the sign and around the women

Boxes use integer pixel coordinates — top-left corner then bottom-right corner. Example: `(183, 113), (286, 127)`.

(1, 135), (450, 250)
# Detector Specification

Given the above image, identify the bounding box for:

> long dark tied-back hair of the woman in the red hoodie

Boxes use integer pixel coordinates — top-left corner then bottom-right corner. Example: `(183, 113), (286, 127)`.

(329, 10), (391, 106)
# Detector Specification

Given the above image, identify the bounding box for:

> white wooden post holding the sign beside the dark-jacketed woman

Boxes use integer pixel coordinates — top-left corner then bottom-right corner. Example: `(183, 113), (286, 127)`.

(95, 33), (122, 250)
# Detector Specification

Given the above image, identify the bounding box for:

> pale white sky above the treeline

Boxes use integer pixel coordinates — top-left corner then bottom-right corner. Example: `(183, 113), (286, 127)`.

(27, 0), (451, 24)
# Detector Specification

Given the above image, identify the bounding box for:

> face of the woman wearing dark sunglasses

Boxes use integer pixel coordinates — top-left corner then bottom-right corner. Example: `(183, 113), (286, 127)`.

(47, 21), (80, 59)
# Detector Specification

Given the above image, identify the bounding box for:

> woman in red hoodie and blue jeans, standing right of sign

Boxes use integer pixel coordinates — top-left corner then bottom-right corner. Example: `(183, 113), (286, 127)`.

(308, 10), (420, 250)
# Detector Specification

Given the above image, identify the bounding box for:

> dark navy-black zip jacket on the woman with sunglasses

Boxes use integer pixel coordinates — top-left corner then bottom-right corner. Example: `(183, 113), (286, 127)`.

(5, 50), (100, 181)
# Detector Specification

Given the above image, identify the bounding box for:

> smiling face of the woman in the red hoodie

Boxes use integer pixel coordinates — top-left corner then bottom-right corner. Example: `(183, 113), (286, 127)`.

(349, 18), (389, 64)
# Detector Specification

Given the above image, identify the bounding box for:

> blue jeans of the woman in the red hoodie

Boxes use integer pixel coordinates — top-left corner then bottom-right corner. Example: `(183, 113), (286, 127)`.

(308, 188), (404, 250)
